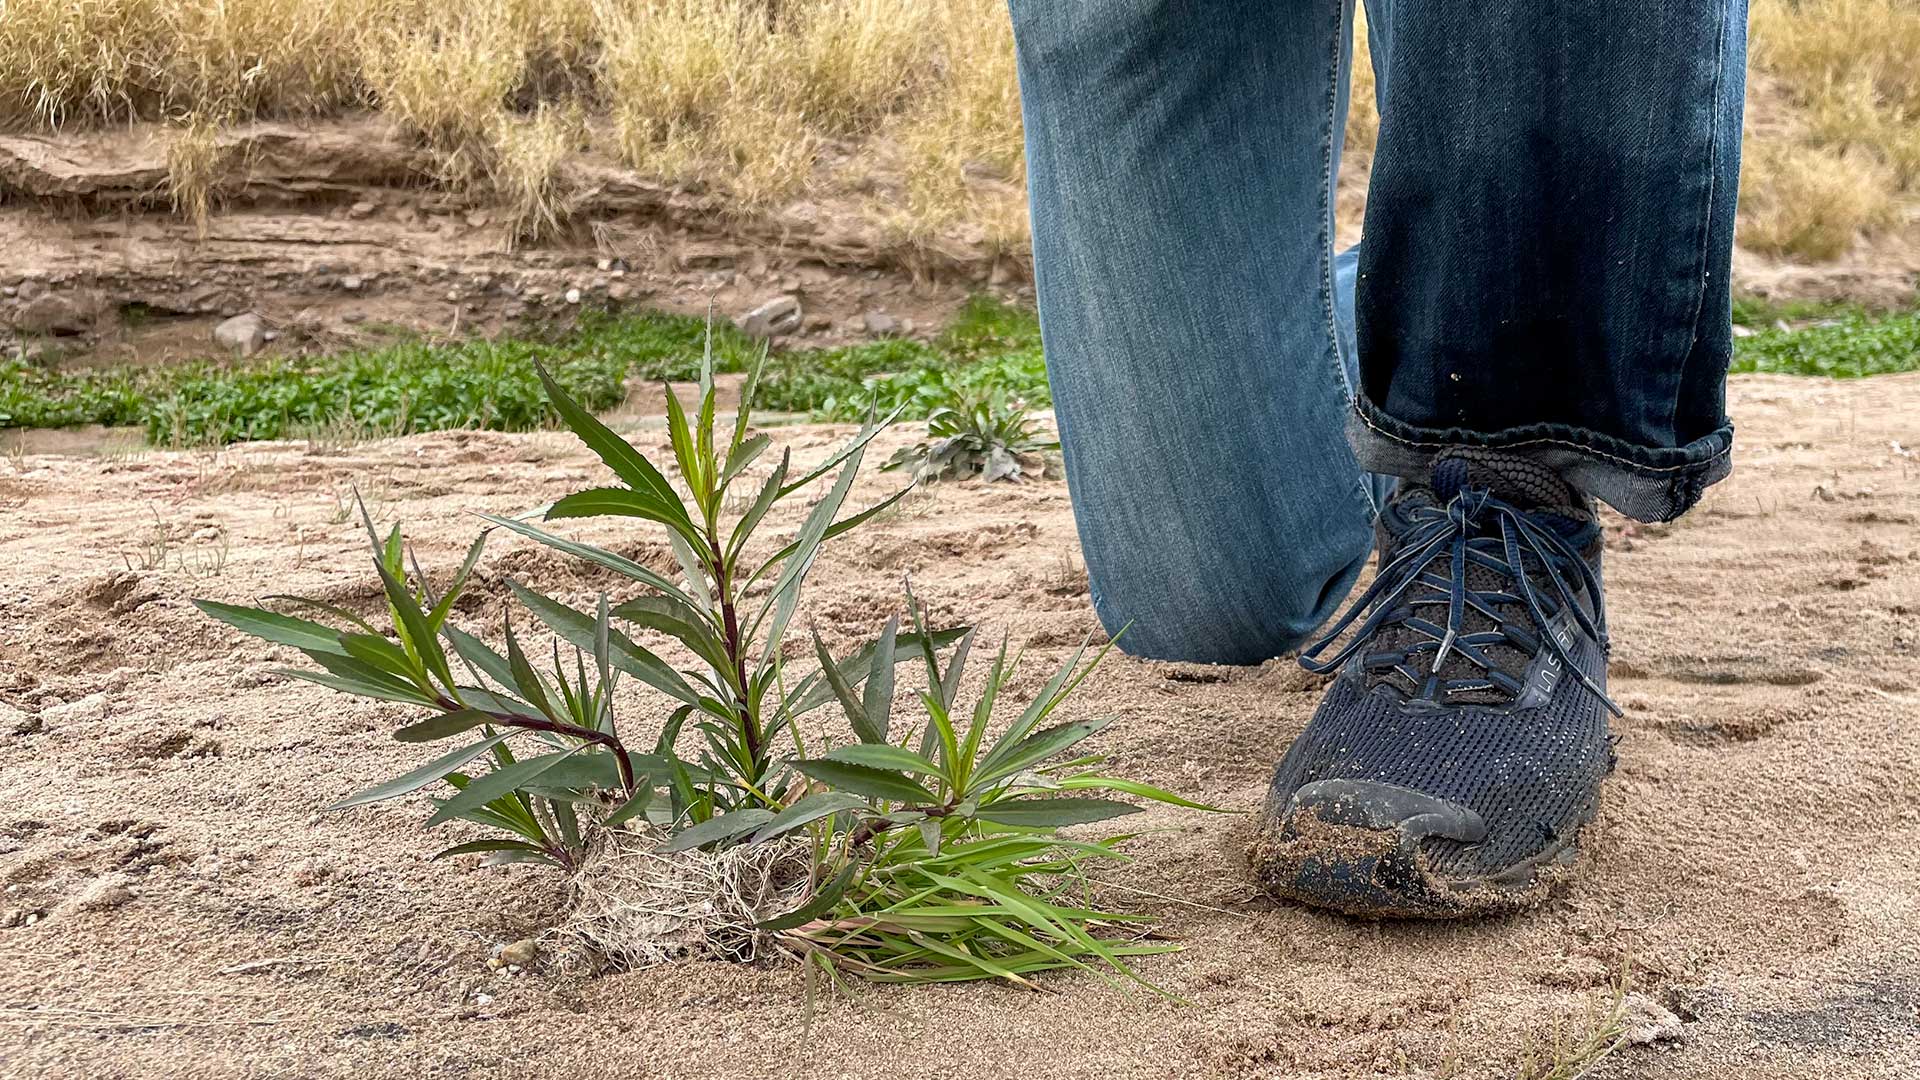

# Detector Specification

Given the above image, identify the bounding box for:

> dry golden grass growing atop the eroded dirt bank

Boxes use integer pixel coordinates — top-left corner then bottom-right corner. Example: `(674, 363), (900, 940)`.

(0, 0), (1920, 258)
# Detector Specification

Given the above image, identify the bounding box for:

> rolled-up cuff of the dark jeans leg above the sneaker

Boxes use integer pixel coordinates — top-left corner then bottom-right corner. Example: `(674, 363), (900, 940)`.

(1346, 398), (1734, 521)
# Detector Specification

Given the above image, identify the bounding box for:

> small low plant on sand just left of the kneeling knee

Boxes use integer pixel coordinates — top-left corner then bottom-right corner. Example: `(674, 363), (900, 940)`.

(881, 390), (1060, 482)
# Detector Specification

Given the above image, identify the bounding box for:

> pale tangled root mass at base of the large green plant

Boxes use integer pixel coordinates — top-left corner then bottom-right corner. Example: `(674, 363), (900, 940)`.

(559, 830), (812, 970)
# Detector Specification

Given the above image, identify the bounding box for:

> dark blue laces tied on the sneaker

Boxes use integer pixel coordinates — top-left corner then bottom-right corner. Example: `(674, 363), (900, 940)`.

(1300, 480), (1622, 717)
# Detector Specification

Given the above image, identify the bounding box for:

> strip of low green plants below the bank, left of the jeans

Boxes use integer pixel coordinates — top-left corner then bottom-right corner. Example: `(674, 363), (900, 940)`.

(0, 298), (1048, 446)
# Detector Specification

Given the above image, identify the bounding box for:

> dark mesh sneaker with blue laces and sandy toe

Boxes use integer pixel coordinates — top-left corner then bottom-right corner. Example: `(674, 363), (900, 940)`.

(1250, 450), (1619, 919)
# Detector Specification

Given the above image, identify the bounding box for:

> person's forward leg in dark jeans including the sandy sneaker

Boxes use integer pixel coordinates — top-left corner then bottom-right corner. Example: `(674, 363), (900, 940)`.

(1254, 0), (1745, 915)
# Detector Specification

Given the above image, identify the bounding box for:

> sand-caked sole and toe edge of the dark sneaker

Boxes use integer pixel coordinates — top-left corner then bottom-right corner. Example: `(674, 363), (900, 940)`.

(1248, 790), (1599, 919)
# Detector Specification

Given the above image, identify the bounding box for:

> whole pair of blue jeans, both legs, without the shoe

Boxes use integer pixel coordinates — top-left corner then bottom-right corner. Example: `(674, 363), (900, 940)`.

(1012, 0), (1745, 663)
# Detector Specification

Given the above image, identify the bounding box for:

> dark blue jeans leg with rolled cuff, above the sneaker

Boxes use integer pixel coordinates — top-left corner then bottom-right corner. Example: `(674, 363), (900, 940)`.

(1356, 0), (1747, 521)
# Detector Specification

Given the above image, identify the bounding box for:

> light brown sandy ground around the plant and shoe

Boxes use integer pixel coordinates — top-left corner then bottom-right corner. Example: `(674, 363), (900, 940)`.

(0, 377), (1920, 1080)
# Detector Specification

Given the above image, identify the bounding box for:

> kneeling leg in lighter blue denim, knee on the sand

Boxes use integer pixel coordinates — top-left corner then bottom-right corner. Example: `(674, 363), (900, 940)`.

(1012, 0), (1373, 663)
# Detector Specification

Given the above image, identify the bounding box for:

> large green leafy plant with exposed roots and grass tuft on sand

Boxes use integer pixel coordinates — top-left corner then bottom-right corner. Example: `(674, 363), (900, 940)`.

(198, 340), (1196, 984)
